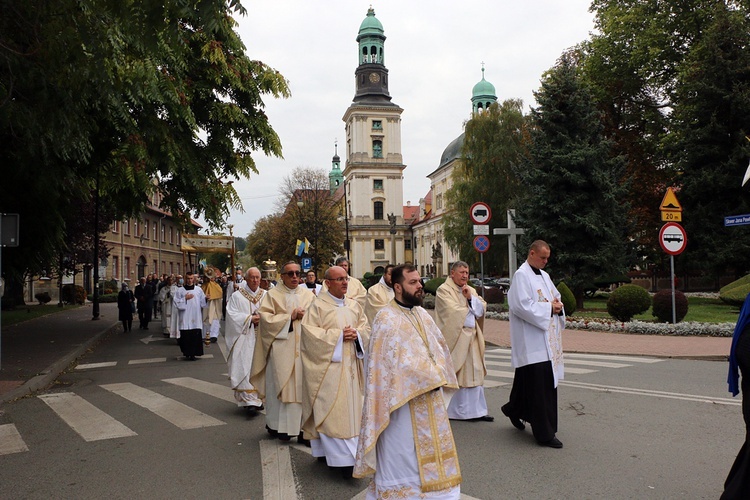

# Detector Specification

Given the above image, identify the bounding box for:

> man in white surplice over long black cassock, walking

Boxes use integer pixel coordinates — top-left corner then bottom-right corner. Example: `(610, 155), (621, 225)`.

(502, 240), (565, 448)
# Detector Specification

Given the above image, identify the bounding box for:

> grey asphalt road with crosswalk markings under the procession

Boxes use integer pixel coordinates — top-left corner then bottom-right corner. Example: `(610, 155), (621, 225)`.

(0, 330), (744, 499)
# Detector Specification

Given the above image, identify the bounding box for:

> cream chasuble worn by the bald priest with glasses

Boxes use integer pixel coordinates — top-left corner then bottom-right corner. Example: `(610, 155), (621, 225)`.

(300, 292), (370, 439)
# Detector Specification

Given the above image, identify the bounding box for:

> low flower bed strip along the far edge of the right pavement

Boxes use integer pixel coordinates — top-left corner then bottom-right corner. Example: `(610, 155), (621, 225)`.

(486, 311), (735, 337)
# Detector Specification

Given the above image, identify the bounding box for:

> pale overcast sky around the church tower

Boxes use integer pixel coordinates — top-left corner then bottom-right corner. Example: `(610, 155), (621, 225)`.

(216, 0), (594, 236)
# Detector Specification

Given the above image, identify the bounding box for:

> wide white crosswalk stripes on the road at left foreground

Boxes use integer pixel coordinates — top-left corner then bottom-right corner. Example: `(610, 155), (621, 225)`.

(0, 377), (236, 456)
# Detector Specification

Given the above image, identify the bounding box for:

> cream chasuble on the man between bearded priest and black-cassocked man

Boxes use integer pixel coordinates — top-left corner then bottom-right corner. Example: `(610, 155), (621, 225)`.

(435, 277), (487, 387)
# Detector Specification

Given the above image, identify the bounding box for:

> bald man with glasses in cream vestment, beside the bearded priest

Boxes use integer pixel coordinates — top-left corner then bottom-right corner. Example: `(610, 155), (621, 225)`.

(300, 266), (370, 477)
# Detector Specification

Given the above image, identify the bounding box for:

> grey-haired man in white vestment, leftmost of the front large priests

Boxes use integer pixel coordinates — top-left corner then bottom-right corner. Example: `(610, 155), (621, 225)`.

(224, 267), (266, 410)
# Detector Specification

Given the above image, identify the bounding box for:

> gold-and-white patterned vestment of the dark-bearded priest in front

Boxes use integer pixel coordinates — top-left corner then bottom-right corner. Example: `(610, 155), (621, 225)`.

(354, 301), (461, 492)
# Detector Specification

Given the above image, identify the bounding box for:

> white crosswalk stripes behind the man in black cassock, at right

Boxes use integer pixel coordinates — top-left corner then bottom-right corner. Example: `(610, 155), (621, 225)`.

(484, 348), (662, 388)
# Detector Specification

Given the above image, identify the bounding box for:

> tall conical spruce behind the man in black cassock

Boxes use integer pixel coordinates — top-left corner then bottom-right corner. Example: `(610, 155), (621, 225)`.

(516, 53), (630, 308)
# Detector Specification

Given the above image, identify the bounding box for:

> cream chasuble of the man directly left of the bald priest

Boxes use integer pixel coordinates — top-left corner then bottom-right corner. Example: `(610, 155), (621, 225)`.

(250, 283), (315, 403)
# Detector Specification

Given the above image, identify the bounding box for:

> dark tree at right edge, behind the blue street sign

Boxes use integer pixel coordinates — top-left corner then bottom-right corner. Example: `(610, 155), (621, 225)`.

(669, 4), (750, 276)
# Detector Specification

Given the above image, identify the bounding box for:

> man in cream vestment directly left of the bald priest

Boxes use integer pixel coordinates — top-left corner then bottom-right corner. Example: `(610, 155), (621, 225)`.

(250, 262), (315, 441)
